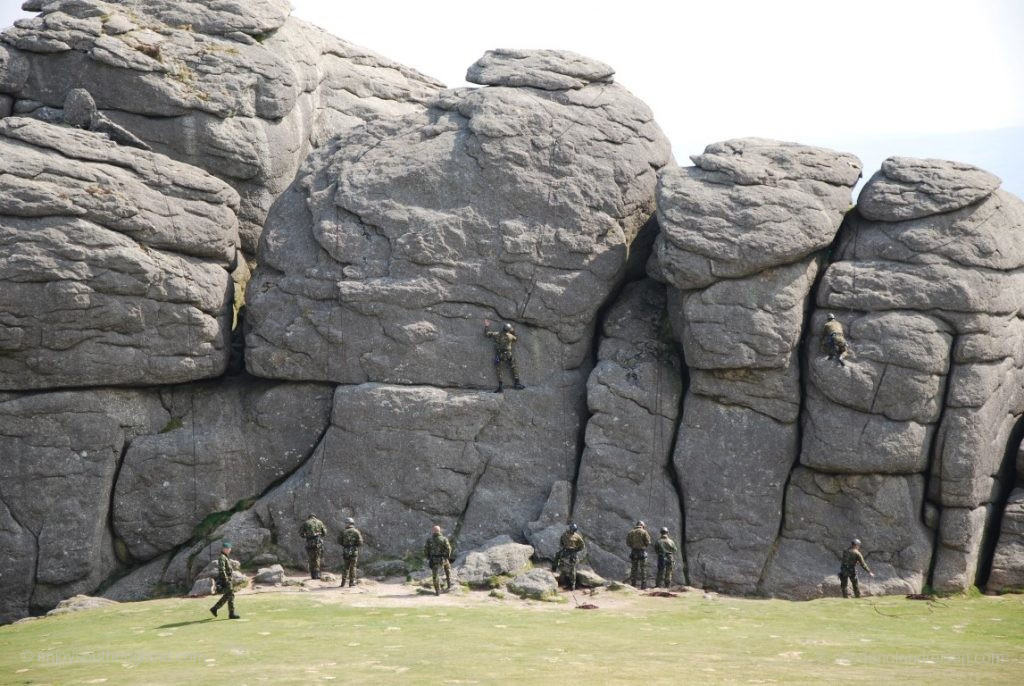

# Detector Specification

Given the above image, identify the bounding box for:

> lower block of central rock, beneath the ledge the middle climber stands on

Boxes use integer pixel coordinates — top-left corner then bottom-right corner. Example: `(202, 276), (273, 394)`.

(215, 375), (582, 566)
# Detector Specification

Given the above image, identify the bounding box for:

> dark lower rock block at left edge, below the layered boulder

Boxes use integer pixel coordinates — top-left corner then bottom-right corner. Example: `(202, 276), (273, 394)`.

(0, 390), (169, 621)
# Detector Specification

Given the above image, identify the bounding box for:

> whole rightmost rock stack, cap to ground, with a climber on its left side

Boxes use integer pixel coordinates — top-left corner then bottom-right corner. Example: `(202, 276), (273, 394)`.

(766, 158), (1024, 597)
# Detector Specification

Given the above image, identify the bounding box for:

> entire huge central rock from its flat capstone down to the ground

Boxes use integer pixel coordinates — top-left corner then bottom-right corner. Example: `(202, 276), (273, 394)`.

(234, 51), (670, 569)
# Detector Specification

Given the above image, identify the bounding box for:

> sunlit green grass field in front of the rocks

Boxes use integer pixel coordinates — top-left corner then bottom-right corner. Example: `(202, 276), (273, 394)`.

(0, 591), (1024, 685)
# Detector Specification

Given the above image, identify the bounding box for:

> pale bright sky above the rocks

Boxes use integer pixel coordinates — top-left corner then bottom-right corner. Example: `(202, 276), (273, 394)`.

(0, 0), (1024, 196)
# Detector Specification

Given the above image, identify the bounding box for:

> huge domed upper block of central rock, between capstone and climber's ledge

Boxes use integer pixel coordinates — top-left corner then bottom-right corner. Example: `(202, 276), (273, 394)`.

(247, 49), (670, 388)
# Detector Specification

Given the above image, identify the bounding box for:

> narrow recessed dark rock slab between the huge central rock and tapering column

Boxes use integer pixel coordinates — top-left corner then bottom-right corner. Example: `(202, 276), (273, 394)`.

(573, 280), (683, 578)
